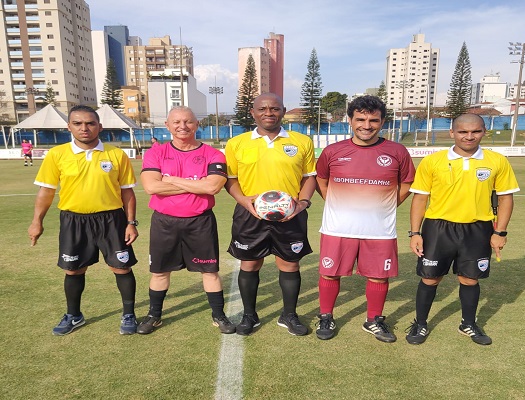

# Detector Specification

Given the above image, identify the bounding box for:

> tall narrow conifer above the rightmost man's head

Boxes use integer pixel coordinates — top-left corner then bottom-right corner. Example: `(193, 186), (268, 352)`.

(447, 42), (472, 118)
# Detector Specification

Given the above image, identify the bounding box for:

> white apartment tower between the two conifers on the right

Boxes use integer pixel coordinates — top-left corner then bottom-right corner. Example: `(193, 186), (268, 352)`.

(385, 33), (439, 110)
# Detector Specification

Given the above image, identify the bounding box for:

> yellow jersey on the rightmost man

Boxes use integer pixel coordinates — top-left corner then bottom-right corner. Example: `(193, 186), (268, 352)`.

(410, 147), (520, 223)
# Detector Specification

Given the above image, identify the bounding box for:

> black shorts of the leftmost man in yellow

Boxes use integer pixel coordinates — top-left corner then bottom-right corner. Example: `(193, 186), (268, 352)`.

(58, 209), (137, 271)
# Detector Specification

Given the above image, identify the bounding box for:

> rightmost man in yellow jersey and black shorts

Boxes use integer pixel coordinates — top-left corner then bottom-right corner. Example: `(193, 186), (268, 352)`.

(406, 114), (519, 345)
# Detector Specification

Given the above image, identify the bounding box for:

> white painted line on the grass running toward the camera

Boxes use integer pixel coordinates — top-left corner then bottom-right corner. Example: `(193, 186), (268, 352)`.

(215, 261), (244, 400)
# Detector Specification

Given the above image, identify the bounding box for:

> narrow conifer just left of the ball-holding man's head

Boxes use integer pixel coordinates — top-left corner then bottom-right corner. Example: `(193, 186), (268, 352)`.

(234, 54), (259, 130)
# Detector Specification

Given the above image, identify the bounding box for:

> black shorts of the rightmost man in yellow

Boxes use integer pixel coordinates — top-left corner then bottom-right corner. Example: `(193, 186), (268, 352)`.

(416, 219), (494, 279)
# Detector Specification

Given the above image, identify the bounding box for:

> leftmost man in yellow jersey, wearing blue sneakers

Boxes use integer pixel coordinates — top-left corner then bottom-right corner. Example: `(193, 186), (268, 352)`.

(28, 105), (138, 335)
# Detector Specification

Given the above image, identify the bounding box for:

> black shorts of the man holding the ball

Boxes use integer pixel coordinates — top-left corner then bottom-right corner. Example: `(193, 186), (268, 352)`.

(228, 204), (312, 262)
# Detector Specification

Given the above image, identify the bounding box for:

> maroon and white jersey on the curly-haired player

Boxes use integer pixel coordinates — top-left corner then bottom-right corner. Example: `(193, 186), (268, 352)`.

(317, 139), (415, 239)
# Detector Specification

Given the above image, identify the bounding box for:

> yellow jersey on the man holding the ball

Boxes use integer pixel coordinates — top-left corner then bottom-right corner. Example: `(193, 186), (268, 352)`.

(226, 128), (316, 197)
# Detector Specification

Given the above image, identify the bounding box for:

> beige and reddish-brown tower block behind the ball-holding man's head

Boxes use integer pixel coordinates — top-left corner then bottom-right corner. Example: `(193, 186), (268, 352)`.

(238, 32), (284, 97)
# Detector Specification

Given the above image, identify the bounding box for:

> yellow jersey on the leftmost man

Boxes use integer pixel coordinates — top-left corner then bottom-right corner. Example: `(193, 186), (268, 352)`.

(35, 141), (136, 214)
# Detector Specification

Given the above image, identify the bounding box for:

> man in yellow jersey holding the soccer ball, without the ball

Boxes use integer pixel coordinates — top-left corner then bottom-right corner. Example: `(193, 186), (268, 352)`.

(226, 93), (315, 336)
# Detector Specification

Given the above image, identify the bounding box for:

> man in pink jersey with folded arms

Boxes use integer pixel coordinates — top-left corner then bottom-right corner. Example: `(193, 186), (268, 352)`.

(137, 106), (235, 334)
